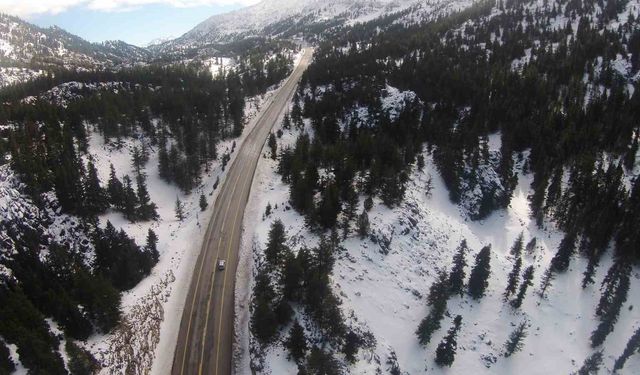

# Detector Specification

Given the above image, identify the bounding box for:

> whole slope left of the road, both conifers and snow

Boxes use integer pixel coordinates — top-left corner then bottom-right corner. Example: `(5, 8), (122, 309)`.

(0, 30), (297, 374)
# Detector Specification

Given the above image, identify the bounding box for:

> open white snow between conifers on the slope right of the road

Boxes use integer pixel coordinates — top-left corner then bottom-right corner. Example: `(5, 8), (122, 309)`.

(236, 101), (640, 375)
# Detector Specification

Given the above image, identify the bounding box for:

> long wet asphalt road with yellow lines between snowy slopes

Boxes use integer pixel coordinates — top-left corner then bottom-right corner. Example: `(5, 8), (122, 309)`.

(171, 48), (313, 375)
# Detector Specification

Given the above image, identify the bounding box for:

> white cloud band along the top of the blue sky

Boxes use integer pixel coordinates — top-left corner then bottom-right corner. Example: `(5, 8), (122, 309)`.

(0, 0), (259, 17)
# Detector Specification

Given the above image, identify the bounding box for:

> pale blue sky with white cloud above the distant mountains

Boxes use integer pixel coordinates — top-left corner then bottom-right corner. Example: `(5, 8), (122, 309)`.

(0, 0), (259, 46)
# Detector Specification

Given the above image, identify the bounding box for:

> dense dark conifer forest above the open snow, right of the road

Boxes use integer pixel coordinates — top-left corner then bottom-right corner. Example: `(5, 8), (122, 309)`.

(292, 2), (640, 261)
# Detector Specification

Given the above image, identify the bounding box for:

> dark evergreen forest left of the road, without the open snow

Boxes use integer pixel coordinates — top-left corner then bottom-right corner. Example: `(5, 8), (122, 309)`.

(0, 39), (293, 374)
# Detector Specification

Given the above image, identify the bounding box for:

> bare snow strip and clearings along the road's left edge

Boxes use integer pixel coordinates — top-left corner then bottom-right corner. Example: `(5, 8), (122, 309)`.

(78, 50), (301, 374)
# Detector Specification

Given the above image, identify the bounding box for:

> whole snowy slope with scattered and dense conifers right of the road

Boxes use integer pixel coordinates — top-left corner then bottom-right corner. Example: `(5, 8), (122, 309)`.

(241, 0), (640, 374)
